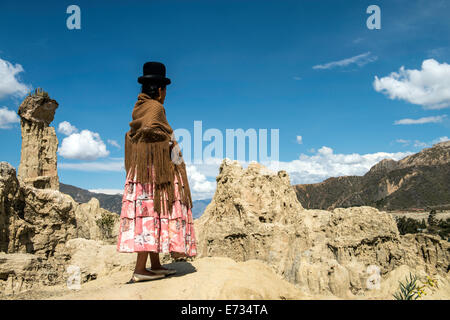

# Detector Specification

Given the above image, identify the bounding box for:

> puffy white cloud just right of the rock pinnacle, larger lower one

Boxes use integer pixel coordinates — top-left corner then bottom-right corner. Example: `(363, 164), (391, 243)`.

(58, 130), (109, 160)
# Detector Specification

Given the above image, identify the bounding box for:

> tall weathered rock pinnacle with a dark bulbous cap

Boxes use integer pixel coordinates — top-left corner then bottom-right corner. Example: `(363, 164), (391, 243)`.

(17, 89), (59, 190)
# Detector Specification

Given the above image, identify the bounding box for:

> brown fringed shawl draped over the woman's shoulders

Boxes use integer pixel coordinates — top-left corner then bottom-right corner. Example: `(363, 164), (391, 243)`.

(125, 93), (192, 215)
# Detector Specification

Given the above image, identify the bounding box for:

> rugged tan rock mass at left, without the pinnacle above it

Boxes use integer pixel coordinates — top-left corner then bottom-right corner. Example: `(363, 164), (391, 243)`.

(0, 162), (122, 294)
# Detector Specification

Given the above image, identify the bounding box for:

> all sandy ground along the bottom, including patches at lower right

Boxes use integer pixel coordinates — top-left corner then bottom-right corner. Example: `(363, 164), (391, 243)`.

(3, 257), (450, 300)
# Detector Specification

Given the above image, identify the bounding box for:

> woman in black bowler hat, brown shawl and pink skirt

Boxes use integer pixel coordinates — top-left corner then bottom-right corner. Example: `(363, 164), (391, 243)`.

(117, 62), (197, 282)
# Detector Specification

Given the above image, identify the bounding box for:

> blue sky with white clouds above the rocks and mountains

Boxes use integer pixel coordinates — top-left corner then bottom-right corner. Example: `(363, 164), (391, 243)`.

(0, 0), (450, 199)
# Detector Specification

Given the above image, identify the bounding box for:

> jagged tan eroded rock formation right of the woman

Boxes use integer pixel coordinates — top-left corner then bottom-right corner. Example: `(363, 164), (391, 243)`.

(195, 160), (450, 298)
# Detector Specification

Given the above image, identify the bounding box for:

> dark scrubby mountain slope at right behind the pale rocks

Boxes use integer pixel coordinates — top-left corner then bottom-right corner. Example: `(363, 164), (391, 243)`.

(294, 141), (450, 210)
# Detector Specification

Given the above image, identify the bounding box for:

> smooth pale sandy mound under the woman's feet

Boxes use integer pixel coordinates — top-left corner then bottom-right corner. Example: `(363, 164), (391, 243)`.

(44, 257), (306, 300)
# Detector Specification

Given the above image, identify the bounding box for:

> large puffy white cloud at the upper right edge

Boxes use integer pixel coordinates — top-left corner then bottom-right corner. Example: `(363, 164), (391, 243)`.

(373, 59), (450, 109)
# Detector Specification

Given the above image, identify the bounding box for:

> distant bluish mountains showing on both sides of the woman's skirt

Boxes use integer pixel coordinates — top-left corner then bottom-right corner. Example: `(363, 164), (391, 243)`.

(59, 183), (211, 219)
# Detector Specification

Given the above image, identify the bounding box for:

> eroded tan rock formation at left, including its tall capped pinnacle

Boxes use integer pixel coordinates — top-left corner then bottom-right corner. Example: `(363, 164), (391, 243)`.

(0, 90), (126, 294)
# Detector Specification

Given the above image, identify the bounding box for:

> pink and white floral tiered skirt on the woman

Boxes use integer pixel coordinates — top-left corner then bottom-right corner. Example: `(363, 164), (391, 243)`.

(117, 169), (197, 256)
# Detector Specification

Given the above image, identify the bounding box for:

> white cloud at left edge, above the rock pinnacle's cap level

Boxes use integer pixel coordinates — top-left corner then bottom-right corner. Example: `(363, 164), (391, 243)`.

(0, 59), (31, 98)
